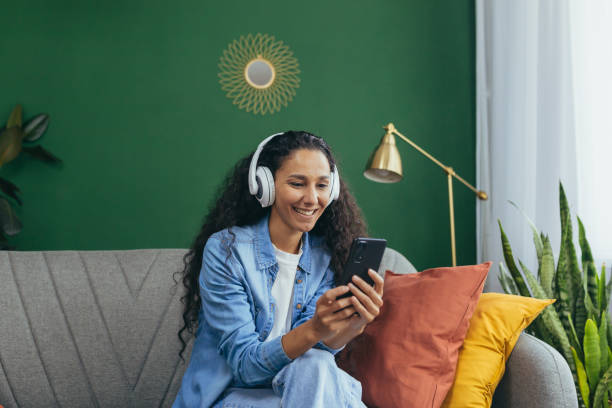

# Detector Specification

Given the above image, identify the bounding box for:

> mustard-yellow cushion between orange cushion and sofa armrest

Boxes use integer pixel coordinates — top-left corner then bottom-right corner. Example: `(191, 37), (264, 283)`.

(442, 293), (555, 408)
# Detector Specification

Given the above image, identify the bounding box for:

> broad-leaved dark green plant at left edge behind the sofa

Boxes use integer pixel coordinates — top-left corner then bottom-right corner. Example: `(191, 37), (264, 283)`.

(0, 105), (61, 249)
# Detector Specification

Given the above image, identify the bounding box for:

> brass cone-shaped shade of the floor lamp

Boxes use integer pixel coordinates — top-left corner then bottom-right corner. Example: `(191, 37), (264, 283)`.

(363, 132), (402, 183)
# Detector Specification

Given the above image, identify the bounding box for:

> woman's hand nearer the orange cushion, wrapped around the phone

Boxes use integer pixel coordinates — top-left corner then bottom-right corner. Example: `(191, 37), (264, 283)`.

(325, 269), (384, 348)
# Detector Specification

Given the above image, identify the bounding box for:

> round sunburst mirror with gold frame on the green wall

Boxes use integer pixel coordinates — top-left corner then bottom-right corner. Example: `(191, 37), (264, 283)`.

(219, 33), (300, 115)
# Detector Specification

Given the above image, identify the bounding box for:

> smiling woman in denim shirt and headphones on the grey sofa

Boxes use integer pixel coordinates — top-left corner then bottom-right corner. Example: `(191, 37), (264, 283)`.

(173, 131), (383, 408)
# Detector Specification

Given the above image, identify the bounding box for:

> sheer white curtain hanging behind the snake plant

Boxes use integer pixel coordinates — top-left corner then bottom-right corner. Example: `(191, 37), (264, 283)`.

(476, 0), (612, 291)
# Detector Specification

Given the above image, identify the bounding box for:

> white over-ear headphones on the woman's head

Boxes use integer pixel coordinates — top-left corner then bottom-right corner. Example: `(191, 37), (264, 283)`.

(249, 132), (340, 207)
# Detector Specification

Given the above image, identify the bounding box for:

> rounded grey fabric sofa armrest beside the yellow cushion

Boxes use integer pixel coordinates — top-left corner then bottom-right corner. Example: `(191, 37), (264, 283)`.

(492, 332), (578, 408)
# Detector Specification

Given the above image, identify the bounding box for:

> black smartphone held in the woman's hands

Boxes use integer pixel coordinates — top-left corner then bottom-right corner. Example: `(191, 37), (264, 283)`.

(338, 238), (387, 299)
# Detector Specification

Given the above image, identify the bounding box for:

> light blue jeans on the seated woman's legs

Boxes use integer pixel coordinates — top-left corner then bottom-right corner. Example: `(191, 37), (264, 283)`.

(213, 348), (365, 408)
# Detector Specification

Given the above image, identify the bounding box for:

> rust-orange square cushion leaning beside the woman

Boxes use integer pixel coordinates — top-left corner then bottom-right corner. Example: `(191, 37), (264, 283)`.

(338, 262), (491, 408)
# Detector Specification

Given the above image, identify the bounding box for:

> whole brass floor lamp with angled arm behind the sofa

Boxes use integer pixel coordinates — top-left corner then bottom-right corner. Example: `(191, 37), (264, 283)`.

(363, 123), (488, 266)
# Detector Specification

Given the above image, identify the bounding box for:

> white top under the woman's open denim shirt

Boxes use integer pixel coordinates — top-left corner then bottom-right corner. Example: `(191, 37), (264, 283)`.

(266, 244), (302, 340)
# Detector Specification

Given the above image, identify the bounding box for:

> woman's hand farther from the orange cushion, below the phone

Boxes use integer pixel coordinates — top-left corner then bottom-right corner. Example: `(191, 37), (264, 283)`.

(311, 285), (356, 341)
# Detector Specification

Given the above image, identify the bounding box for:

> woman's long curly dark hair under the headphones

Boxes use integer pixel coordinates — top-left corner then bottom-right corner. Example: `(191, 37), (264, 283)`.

(177, 130), (367, 358)
